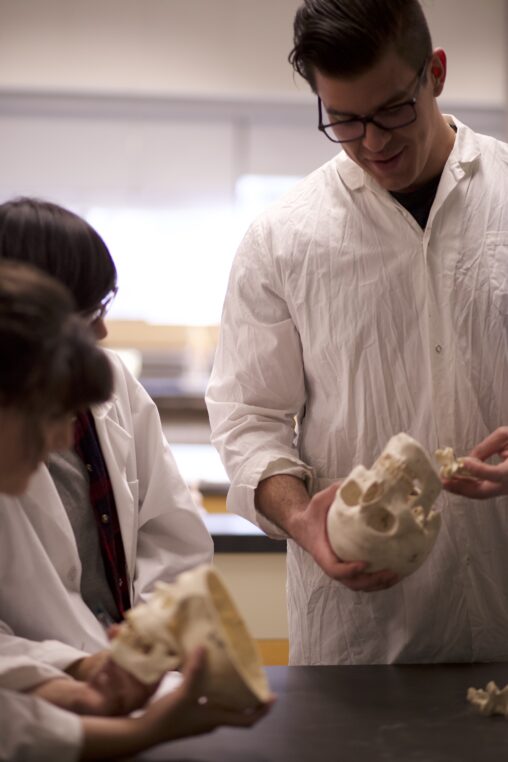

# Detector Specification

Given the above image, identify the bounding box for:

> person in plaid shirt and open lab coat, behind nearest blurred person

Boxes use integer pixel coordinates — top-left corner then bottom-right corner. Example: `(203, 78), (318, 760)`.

(0, 198), (213, 690)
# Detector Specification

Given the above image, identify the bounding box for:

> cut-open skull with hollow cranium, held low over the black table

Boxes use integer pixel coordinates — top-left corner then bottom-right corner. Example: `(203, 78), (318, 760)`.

(111, 564), (270, 709)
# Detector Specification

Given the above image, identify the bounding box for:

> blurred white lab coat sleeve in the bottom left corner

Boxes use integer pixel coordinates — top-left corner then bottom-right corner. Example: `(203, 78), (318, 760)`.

(0, 689), (83, 762)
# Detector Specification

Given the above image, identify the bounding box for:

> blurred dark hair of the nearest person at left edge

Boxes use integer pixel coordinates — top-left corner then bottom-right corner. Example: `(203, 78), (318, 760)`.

(0, 262), (113, 416)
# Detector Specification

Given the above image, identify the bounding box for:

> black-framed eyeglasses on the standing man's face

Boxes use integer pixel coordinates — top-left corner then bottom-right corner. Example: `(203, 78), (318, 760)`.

(318, 58), (430, 143)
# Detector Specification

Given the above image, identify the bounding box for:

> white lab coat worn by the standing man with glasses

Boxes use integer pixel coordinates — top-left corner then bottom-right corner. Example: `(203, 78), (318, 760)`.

(207, 120), (508, 664)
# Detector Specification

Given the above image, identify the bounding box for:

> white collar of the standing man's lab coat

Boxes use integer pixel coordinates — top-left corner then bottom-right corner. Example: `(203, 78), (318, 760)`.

(336, 114), (480, 193)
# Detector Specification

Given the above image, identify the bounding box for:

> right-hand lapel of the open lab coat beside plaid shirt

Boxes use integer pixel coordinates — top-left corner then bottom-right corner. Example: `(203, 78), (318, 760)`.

(92, 400), (138, 597)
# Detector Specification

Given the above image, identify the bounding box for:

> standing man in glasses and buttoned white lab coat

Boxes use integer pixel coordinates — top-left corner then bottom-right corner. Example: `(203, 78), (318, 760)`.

(206, 0), (508, 664)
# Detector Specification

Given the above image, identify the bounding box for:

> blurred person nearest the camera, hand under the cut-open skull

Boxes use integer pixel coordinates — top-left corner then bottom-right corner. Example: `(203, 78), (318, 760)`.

(0, 262), (268, 762)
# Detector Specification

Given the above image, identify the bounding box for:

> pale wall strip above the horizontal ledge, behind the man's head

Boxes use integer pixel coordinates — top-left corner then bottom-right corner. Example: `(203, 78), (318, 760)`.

(0, 0), (507, 105)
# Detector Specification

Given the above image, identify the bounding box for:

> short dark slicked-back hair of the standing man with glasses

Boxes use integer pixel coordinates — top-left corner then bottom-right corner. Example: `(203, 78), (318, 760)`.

(289, 0), (432, 90)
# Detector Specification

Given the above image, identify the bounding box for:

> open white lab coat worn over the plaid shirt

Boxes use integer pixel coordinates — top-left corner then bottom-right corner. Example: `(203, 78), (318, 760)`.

(0, 352), (213, 652)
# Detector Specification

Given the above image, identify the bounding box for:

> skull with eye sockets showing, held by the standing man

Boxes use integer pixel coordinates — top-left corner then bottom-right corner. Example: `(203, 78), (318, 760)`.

(327, 434), (441, 577)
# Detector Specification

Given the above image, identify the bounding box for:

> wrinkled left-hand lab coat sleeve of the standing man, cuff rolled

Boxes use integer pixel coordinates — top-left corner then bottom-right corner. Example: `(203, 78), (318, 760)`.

(206, 217), (313, 538)
